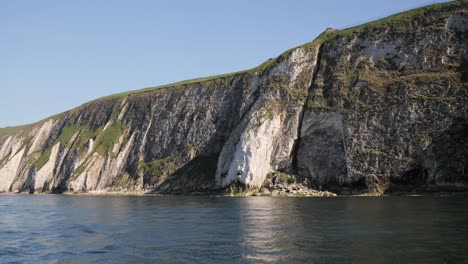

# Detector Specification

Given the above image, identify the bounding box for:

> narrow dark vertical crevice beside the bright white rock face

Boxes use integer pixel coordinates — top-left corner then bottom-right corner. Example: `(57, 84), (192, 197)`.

(290, 44), (323, 174)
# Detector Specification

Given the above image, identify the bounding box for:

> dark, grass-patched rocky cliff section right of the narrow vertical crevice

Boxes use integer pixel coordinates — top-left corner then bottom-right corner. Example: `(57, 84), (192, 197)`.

(297, 2), (468, 191)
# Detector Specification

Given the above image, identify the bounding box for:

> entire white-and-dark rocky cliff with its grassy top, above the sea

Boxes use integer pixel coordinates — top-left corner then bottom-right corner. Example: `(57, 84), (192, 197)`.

(0, 1), (468, 192)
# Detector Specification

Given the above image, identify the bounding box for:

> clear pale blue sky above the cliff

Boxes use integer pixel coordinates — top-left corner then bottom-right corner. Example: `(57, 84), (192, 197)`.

(0, 0), (452, 127)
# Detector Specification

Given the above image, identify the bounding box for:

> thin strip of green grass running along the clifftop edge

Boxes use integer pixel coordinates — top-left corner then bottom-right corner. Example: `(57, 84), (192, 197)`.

(0, 0), (462, 136)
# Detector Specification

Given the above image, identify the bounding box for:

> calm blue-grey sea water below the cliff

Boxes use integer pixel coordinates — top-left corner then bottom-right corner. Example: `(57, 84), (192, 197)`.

(0, 195), (468, 263)
